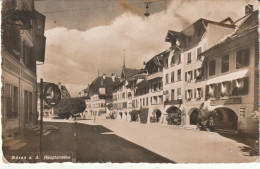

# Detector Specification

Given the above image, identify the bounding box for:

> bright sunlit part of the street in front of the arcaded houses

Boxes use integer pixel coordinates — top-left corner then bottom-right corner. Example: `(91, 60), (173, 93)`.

(78, 119), (258, 163)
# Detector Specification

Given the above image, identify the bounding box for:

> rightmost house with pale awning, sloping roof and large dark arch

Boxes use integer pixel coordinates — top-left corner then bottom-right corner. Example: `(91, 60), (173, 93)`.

(201, 8), (259, 134)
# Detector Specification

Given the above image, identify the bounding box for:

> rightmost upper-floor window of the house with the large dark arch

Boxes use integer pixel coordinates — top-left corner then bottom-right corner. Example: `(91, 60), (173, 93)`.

(236, 49), (249, 69)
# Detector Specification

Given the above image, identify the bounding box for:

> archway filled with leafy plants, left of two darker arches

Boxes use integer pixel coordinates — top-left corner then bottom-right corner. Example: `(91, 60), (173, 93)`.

(166, 106), (182, 125)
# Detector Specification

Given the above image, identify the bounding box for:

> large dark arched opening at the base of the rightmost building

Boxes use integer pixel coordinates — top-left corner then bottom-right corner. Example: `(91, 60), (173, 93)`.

(214, 108), (238, 131)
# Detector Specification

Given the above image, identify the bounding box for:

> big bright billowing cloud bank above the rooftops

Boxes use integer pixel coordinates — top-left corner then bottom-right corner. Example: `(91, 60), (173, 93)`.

(38, 0), (257, 96)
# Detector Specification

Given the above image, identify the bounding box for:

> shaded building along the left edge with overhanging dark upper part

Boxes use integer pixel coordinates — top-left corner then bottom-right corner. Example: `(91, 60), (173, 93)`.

(1, 0), (46, 140)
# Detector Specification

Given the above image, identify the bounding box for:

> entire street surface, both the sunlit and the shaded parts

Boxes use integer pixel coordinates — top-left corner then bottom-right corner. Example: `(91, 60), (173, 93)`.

(3, 119), (258, 163)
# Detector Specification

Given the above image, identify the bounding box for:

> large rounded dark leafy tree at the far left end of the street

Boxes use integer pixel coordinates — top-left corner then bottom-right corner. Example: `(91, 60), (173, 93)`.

(54, 98), (86, 118)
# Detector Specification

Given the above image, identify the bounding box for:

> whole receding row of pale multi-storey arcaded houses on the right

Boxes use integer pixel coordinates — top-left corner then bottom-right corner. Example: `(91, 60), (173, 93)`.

(79, 5), (259, 134)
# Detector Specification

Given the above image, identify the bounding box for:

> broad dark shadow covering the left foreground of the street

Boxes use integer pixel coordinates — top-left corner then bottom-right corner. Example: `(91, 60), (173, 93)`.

(4, 122), (175, 163)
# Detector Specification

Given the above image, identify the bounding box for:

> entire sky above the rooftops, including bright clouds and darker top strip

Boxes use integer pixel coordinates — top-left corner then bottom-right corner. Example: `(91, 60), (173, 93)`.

(35, 0), (258, 96)
